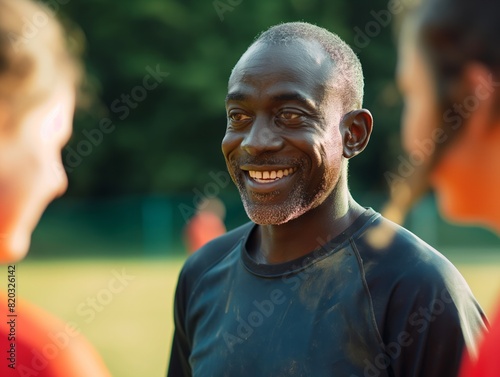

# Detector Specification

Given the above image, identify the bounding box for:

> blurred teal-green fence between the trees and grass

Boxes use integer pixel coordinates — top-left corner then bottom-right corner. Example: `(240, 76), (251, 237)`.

(29, 195), (498, 258)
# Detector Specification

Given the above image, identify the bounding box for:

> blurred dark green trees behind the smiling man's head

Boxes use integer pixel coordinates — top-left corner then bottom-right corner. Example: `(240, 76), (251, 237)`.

(61, 0), (400, 197)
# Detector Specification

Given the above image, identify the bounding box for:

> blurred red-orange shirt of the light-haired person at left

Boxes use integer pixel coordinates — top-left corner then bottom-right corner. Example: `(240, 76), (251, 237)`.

(0, 292), (111, 377)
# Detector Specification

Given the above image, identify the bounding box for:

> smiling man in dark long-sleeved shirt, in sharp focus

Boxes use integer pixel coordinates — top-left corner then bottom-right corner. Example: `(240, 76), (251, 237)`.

(168, 23), (484, 377)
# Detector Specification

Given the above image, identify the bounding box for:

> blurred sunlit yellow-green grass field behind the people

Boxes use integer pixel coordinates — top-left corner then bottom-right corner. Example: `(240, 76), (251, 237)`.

(9, 254), (500, 377)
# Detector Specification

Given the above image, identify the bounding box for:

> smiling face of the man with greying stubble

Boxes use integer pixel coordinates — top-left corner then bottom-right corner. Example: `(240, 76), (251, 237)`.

(222, 40), (344, 224)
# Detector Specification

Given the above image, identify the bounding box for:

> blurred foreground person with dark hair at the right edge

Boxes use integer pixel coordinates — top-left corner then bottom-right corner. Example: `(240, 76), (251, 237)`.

(394, 0), (500, 377)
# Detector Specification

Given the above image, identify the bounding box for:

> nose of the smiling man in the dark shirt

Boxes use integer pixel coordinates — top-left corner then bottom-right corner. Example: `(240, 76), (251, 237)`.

(241, 119), (283, 156)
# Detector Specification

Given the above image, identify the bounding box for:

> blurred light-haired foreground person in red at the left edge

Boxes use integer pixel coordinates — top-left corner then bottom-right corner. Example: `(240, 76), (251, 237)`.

(0, 0), (110, 377)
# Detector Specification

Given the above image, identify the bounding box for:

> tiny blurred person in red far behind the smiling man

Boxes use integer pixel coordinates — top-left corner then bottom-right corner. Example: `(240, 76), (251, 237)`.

(184, 198), (226, 254)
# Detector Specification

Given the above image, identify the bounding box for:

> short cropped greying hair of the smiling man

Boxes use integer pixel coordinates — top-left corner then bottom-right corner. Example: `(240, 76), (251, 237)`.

(254, 22), (364, 112)
